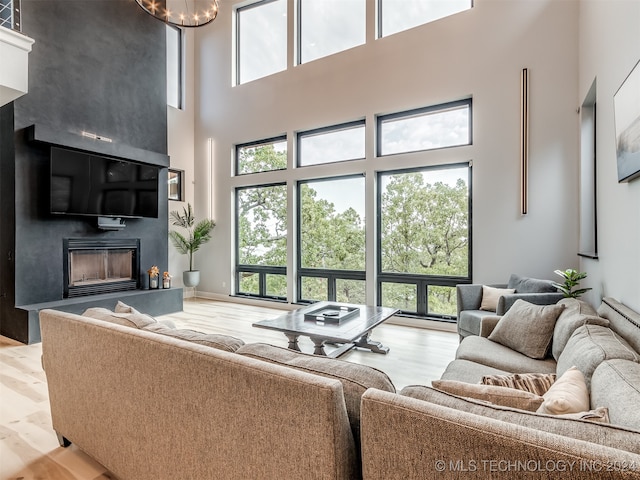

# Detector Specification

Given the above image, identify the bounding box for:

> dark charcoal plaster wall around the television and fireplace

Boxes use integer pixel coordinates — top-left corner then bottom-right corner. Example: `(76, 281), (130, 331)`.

(2, 0), (178, 344)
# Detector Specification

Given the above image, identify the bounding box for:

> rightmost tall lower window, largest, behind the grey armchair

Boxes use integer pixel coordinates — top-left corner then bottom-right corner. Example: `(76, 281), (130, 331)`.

(378, 164), (471, 318)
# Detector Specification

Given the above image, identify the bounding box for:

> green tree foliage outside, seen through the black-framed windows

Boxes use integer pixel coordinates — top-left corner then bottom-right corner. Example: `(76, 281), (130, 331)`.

(237, 145), (469, 315)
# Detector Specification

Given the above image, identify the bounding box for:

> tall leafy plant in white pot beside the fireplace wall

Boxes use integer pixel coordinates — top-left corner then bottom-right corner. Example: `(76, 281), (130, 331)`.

(169, 203), (216, 287)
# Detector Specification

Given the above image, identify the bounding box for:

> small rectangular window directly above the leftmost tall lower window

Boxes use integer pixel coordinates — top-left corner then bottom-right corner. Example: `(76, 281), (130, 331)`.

(236, 136), (287, 175)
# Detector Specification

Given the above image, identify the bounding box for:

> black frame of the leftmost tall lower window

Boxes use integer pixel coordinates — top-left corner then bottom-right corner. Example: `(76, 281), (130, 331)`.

(234, 182), (289, 302)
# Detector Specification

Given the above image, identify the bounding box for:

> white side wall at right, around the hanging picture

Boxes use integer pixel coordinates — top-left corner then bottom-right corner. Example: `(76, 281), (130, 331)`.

(578, 0), (640, 311)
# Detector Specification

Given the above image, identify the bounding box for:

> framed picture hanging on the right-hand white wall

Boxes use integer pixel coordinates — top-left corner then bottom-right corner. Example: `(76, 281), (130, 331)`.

(613, 58), (640, 182)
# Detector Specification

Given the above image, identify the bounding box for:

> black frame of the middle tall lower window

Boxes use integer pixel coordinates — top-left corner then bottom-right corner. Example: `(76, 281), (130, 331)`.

(295, 173), (367, 304)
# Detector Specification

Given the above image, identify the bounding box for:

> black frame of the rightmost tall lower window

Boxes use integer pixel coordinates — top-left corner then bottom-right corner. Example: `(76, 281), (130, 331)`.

(375, 161), (473, 323)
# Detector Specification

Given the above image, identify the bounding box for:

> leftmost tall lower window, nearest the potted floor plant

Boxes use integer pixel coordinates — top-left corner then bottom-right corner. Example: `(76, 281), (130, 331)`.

(236, 184), (287, 300)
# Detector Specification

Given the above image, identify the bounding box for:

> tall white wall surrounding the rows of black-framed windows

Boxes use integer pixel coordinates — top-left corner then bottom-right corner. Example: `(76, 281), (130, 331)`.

(189, 0), (580, 302)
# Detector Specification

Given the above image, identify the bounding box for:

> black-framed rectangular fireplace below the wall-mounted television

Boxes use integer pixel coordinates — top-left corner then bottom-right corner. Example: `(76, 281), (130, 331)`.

(63, 238), (140, 298)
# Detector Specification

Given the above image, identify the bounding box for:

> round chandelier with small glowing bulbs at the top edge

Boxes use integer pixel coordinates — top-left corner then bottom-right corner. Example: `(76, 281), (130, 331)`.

(136, 0), (218, 27)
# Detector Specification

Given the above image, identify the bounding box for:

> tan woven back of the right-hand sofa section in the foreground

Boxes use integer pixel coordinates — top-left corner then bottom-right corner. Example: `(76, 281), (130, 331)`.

(361, 389), (640, 480)
